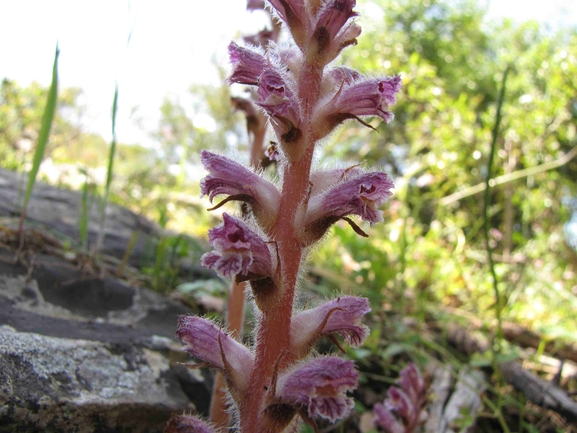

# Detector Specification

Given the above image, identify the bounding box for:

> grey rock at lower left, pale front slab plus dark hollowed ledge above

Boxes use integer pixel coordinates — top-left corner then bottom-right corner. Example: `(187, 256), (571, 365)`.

(0, 259), (212, 432)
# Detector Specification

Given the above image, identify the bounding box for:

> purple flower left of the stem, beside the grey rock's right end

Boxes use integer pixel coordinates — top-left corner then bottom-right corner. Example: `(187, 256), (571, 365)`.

(176, 316), (254, 392)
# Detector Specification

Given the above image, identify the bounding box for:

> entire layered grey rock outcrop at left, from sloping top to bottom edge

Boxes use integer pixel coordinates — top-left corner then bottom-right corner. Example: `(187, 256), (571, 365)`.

(0, 169), (213, 433)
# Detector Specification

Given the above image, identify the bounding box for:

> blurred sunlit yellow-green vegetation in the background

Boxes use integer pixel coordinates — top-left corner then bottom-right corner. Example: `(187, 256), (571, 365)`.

(0, 0), (577, 431)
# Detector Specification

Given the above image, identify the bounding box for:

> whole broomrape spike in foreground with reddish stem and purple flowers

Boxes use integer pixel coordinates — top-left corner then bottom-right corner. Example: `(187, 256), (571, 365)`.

(166, 0), (401, 433)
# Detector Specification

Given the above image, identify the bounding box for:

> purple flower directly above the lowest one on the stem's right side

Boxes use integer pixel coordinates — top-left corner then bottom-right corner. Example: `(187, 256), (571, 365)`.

(291, 296), (371, 356)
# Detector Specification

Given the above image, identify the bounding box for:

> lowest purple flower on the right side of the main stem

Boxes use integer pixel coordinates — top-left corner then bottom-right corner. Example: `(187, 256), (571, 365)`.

(276, 356), (359, 422)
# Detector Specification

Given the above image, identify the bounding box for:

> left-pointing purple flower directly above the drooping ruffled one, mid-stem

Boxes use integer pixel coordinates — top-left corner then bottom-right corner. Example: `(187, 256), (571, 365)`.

(200, 150), (280, 228)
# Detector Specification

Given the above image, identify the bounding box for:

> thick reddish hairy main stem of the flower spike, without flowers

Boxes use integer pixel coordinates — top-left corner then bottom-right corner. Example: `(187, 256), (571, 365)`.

(239, 65), (322, 433)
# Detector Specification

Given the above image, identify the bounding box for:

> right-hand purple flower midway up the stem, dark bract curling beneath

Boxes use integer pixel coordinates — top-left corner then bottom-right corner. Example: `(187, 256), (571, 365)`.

(300, 172), (394, 227)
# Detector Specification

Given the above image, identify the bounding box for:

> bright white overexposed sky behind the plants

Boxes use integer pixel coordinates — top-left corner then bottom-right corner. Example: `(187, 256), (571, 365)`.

(0, 0), (577, 145)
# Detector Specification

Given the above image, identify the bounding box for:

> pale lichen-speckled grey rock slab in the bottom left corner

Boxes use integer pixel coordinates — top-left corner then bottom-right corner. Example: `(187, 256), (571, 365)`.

(0, 328), (209, 433)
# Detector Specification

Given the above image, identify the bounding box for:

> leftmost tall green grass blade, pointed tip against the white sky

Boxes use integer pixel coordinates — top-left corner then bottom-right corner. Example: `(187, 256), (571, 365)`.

(18, 44), (60, 235)
